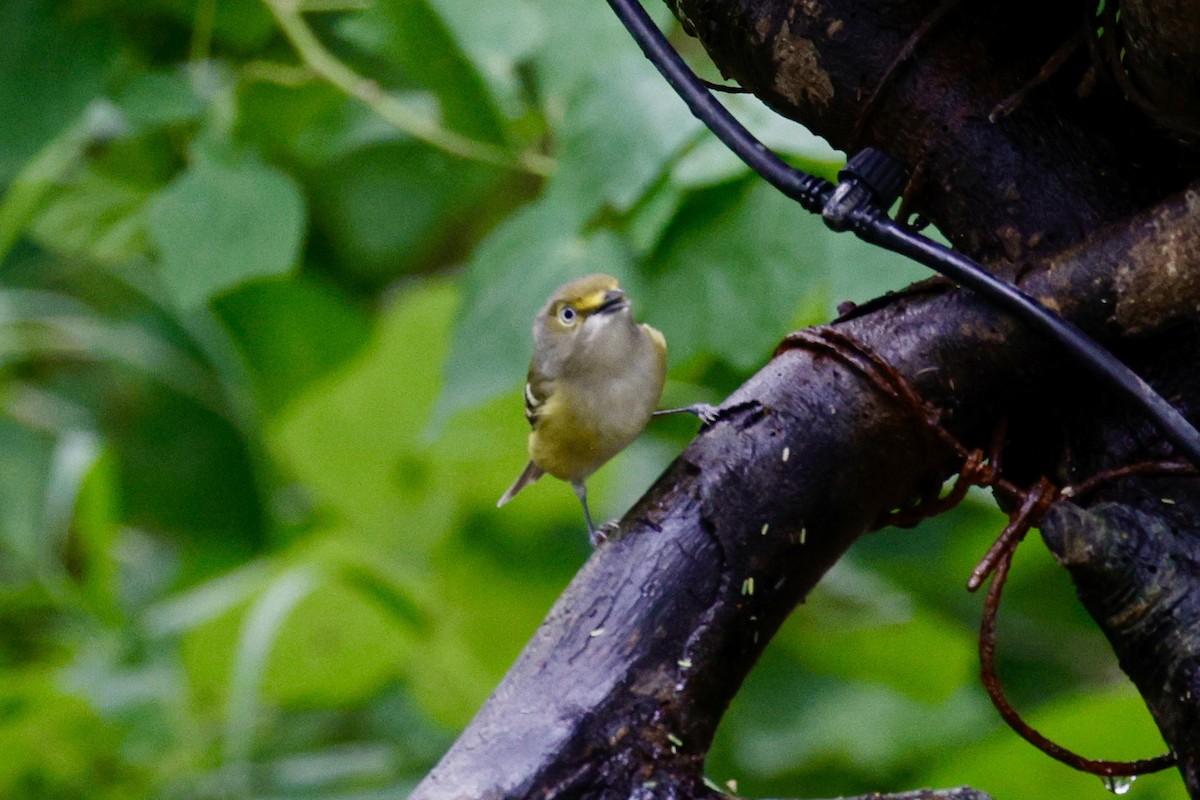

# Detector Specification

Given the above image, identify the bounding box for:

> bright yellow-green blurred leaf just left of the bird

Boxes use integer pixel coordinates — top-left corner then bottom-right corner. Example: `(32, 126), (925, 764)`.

(269, 283), (456, 563)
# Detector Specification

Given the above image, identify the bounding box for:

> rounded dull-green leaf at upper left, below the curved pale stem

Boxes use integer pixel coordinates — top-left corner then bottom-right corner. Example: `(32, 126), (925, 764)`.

(149, 158), (305, 308)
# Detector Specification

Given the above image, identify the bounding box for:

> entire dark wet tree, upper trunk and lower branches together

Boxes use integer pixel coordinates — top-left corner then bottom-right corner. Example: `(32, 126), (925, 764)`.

(413, 0), (1200, 800)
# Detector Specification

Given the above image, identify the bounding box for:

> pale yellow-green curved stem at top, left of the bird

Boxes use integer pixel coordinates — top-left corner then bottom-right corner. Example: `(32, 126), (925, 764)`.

(263, 0), (554, 176)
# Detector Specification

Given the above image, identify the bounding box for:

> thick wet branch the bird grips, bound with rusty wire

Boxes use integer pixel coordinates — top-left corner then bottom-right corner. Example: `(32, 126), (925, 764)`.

(413, 178), (1200, 800)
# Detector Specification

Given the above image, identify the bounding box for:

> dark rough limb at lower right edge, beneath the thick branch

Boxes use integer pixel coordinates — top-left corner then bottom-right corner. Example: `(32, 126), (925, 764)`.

(1042, 326), (1200, 796)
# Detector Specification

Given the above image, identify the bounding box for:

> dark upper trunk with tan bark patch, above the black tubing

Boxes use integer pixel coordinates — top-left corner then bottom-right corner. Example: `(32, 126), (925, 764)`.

(680, 0), (1184, 269)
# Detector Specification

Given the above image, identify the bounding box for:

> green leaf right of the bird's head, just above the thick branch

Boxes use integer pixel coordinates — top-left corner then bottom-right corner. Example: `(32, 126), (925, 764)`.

(644, 180), (828, 369)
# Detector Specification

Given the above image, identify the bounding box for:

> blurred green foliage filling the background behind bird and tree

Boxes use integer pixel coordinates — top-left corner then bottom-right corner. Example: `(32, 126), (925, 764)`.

(0, 0), (1182, 800)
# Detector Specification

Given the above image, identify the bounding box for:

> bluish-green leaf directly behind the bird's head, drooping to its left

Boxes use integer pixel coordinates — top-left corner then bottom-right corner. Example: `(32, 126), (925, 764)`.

(436, 200), (636, 423)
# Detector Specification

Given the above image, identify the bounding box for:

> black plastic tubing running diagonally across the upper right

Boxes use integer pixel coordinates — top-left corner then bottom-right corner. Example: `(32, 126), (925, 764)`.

(608, 0), (1200, 467)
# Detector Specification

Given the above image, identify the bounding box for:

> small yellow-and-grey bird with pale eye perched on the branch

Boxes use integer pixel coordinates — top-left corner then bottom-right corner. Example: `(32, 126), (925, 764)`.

(496, 275), (715, 545)
